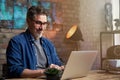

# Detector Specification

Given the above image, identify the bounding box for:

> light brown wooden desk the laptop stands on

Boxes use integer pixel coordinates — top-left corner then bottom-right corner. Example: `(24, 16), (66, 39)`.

(6, 70), (120, 80)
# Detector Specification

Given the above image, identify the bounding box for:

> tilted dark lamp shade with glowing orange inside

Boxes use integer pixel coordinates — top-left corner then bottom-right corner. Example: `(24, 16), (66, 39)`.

(66, 25), (84, 41)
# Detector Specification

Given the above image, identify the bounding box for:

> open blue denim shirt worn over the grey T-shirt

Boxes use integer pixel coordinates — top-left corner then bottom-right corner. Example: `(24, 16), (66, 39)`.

(6, 30), (62, 77)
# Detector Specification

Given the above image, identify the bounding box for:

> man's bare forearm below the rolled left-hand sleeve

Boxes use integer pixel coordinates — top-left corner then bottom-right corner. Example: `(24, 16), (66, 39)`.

(21, 69), (45, 78)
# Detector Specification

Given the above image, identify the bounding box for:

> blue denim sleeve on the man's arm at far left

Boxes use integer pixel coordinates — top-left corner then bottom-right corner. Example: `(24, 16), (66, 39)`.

(6, 39), (24, 77)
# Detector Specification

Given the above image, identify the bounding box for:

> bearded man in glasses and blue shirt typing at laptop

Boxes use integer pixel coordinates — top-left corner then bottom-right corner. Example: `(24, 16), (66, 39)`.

(6, 6), (64, 78)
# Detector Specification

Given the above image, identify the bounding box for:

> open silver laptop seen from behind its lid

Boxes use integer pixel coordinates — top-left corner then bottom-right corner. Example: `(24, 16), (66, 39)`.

(61, 51), (98, 80)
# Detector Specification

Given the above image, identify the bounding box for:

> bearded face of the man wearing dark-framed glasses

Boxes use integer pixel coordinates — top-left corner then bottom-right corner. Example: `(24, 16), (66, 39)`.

(28, 15), (47, 38)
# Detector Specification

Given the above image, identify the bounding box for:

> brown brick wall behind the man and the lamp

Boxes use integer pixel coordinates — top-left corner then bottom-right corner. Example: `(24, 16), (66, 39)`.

(0, 0), (108, 75)
